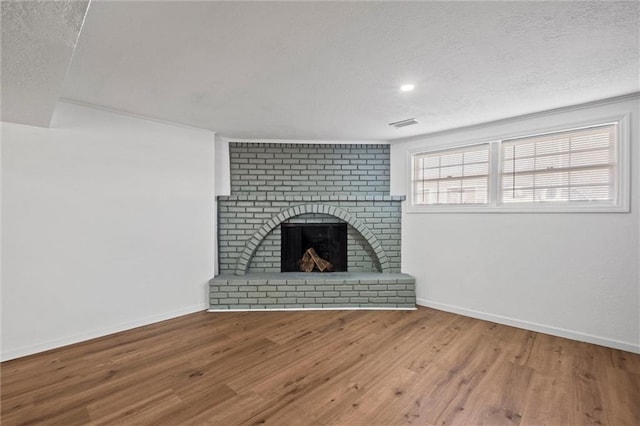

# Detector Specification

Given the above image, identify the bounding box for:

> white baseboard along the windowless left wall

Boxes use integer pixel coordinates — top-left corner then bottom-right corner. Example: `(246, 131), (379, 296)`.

(2, 305), (207, 362)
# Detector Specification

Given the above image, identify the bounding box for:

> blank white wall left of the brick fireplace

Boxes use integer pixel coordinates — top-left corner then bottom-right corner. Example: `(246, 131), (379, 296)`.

(2, 103), (215, 359)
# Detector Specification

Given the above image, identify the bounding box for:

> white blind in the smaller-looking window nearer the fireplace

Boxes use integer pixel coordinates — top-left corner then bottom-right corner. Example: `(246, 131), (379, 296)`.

(413, 144), (489, 205)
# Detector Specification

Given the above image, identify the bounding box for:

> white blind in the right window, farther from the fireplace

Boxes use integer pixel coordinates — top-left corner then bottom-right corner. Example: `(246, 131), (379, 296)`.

(501, 124), (618, 203)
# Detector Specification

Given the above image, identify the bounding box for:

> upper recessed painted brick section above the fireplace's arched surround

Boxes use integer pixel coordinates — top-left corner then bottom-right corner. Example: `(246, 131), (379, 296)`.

(229, 143), (390, 195)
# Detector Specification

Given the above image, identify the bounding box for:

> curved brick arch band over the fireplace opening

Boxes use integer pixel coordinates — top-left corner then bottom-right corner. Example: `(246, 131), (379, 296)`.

(235, 204), (391, 275)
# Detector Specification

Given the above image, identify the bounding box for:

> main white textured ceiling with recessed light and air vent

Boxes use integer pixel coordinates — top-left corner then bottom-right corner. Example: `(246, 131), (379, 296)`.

(2, 0), (640, 140)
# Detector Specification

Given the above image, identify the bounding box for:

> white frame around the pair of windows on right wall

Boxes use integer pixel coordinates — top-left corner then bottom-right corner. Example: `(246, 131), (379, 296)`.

(406, 114), (631, 213)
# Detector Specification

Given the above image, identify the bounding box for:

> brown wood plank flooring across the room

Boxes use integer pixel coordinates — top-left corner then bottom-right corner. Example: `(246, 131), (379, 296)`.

(0, 308), (640, 426)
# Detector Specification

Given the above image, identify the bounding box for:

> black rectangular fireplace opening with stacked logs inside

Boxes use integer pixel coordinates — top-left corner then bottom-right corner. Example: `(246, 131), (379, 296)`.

(280, 223), (347, 272)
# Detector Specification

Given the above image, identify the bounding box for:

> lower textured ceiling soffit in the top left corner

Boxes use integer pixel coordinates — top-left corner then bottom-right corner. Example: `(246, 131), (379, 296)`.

(0, 0), (89, 127)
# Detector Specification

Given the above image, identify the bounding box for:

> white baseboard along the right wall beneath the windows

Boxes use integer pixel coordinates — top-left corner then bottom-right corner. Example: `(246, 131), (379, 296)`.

(416, 299), (640, 353)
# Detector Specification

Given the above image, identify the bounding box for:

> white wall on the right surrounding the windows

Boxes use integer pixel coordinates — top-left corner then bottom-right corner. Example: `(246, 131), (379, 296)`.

(391, 97), (640, 352)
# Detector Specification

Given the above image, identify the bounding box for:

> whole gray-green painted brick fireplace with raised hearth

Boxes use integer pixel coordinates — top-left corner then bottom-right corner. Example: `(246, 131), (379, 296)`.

(210, 143), (415, 310)
